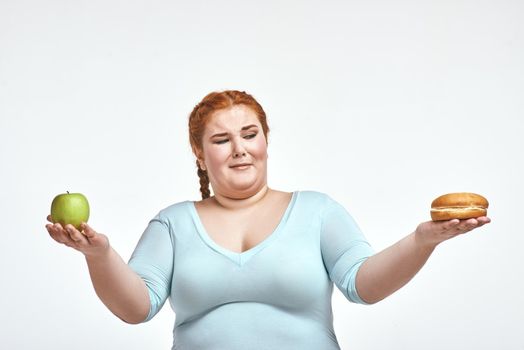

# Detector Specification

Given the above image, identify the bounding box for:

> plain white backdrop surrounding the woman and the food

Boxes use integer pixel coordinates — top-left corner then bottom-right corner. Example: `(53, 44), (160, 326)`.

(0, 0), (524, 350)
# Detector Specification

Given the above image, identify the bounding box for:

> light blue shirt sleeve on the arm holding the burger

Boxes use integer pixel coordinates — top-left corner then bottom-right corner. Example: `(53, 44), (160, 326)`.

(320, 200), (373, 304)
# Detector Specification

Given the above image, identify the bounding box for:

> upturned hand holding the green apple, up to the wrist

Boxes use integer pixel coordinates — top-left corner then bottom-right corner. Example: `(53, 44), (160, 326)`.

(46, 215), (110, 257)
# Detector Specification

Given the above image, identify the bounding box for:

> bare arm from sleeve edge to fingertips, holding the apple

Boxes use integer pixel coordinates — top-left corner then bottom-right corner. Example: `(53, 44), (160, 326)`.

(46, 216), (150, 324)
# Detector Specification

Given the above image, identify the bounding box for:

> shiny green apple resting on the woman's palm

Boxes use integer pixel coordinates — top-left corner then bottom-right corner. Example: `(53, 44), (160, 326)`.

(51, 191), (89, 229)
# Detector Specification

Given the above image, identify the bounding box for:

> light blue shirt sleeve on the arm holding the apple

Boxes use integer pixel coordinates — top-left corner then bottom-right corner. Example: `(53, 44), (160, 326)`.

(128, 214), (173, 322)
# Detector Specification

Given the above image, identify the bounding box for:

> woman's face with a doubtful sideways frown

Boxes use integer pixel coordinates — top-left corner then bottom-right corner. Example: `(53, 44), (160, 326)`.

(199, 105), (267, 198)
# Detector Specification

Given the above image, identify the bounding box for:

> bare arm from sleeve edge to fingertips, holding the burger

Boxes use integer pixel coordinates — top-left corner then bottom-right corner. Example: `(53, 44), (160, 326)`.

(356, 216), (491, 304)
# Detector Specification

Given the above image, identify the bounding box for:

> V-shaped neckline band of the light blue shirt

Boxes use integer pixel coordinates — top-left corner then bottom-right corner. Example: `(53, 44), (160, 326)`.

(188, 191), (299, 266)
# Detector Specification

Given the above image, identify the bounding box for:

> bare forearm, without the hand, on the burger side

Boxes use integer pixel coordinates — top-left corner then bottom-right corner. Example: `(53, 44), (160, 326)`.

(356, 233), (436, 303)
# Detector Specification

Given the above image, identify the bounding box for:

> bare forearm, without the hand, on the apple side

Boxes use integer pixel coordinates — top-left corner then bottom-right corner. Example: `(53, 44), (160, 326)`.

(86, 248), (150, 323)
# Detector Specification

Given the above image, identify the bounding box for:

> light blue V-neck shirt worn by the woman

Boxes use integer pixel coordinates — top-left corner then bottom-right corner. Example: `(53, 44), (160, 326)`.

(129, 191), (373, 350)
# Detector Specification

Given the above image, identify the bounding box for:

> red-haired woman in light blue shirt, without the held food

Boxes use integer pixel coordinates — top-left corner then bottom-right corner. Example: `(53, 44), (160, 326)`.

(46, 91), (490, 350)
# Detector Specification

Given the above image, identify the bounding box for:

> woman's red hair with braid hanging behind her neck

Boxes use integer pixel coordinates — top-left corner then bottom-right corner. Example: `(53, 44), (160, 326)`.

(189, 90), (269, 199)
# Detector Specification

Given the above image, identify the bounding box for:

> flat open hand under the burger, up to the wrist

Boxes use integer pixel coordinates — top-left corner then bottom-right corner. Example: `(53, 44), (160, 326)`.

(415, 216), (491, 247)
